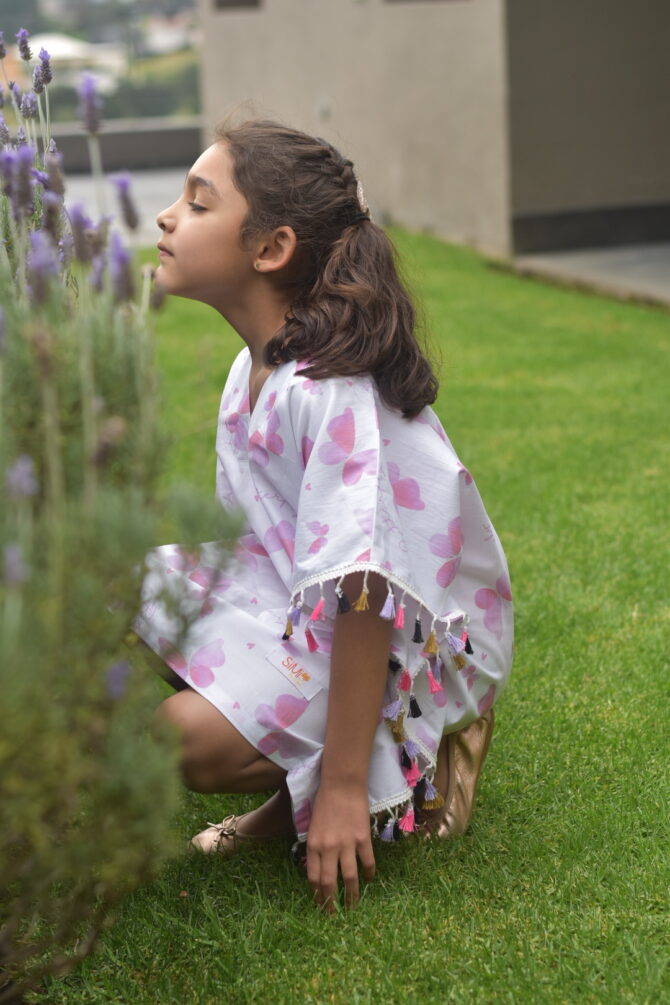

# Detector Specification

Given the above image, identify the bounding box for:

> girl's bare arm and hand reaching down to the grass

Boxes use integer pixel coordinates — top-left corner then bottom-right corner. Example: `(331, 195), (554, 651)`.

(307, 573), (393, 911)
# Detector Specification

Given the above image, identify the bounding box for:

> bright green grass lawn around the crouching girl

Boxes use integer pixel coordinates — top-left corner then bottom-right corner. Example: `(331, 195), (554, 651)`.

(35, 231), (670, 1005)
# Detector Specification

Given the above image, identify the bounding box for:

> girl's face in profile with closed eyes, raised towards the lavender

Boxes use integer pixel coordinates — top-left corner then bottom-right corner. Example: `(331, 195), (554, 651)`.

(156, 142), (255, 313)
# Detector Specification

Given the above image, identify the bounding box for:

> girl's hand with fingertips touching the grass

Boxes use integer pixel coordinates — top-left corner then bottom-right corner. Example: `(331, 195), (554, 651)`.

(307, 784), (375, 914)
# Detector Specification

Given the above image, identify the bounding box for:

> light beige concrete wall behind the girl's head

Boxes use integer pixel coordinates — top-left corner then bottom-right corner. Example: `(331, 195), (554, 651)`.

(200, 0), (509, 255)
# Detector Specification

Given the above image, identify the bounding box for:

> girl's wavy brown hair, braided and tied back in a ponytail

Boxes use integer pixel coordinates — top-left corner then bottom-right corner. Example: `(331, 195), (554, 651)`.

(216, 121), (438, 417)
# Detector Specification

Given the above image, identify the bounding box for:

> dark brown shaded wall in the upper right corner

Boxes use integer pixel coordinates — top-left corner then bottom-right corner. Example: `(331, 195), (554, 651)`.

(506, 0), (670, 247)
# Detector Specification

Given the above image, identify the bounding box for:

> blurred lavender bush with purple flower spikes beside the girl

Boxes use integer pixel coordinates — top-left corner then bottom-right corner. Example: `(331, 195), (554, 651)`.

(0, 31), (235, 1002)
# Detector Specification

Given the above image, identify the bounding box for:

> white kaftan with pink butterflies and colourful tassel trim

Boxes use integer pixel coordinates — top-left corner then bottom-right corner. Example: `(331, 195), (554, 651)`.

(136, 349), (512, 839)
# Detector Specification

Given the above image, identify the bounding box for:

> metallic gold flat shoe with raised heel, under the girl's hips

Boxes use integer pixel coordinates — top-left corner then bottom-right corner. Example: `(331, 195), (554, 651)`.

(423, 709), (495, 838)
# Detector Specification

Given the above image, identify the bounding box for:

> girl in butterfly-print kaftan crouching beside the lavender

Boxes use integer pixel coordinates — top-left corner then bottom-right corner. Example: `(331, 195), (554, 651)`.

(138, 122), (512, 910)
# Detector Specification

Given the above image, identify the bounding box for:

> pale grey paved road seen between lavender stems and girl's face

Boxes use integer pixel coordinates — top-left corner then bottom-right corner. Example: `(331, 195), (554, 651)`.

(65, 166), (189, 246)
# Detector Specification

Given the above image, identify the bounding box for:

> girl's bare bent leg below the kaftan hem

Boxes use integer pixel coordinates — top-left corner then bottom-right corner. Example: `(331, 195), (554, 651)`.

(156, 689), (294, 837)
